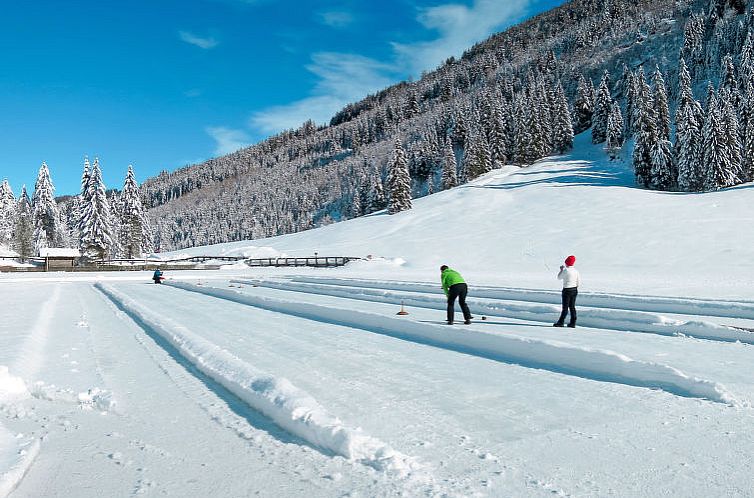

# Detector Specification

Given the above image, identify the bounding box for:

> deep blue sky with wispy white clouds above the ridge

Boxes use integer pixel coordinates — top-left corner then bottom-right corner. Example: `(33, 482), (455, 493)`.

(0, 0), (564, 195)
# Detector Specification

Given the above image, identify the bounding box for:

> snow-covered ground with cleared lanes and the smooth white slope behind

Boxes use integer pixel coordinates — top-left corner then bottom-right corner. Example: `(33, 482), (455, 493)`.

(0, 135), (754, 497)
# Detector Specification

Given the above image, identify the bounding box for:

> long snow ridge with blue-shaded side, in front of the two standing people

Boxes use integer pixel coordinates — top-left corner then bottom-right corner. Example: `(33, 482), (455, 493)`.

(166, 282), (749, 407)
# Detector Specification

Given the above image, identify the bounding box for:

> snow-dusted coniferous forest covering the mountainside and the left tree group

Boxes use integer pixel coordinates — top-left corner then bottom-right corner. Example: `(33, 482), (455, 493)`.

(0, 0), (754, 258)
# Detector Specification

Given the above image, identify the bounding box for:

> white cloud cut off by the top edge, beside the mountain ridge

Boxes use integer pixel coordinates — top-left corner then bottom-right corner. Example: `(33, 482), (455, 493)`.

(393, 0), (530, 75)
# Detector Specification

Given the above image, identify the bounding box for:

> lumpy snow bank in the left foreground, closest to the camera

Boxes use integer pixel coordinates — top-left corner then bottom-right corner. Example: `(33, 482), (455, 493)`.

(95, 283), (420, 476)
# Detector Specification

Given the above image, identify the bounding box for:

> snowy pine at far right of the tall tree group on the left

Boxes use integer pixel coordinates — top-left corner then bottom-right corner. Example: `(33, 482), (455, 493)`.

(120, 164), (152, 259)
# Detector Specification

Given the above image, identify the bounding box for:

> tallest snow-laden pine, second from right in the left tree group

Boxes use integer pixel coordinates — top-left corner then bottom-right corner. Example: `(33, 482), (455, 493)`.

(80, 158), (116, 259)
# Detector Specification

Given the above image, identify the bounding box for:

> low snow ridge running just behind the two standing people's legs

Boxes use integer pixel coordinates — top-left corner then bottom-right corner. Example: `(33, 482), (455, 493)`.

(238, 278), (754, 344)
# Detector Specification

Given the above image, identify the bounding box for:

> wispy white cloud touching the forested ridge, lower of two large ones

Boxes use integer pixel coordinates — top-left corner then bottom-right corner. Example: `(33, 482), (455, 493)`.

(249, 52), (395, 135)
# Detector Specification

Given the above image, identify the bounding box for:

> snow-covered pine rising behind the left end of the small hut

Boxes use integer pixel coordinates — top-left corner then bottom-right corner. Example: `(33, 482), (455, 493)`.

(32, 162), (63, 253)
